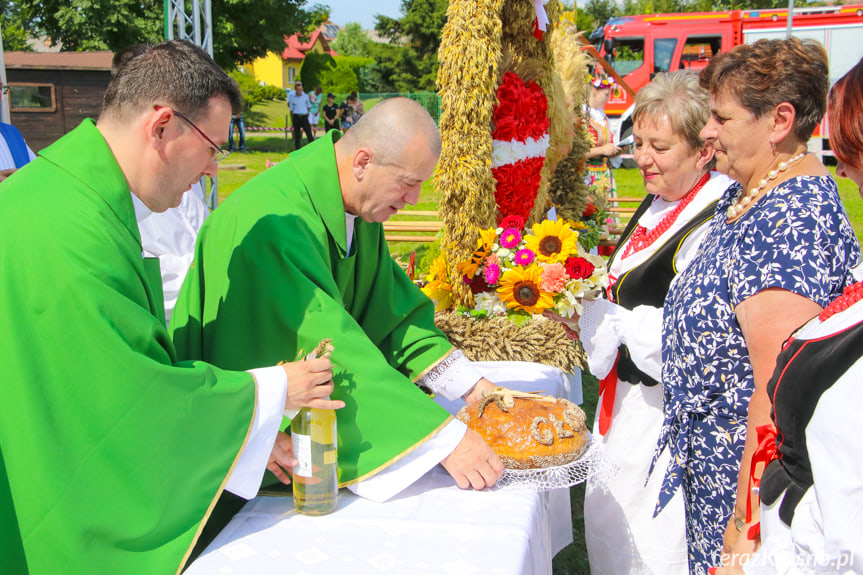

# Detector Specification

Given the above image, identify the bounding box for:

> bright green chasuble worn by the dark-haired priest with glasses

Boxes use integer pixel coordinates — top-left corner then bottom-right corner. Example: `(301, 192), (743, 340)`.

(0, 120), (256, 575)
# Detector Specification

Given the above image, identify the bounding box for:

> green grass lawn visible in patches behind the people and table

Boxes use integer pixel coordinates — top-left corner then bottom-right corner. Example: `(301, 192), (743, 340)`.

(214, 145), (863, 575)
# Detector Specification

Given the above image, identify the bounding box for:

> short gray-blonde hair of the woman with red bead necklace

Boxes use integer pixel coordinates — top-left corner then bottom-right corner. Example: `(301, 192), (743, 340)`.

(632, 70), (710, 150)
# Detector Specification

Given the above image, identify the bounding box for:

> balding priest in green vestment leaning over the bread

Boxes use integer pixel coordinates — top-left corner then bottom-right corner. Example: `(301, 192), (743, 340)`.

(171, 98), (503, 499)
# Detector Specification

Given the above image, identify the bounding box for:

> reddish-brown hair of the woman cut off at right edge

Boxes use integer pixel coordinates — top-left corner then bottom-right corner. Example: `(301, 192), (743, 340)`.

(827, 60), (863, 170)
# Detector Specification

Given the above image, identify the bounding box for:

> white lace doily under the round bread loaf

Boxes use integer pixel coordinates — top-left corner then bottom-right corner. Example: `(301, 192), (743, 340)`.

(496, 435), (617, 491)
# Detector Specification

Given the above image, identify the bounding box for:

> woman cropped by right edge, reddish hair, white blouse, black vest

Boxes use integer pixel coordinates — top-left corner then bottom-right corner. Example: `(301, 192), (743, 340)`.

(718, 55), (863, 575)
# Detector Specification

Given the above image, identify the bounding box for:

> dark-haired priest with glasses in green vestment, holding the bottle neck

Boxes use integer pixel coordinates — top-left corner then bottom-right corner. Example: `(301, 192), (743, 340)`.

(0, 42), (342, 575)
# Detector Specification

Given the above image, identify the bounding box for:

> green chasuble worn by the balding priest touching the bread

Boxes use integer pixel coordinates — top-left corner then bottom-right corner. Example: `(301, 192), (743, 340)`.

(171, 131), (451, 486)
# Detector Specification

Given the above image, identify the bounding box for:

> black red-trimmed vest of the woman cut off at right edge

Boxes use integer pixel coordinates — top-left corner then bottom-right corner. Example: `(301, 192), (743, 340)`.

(760, 321), (863, 526)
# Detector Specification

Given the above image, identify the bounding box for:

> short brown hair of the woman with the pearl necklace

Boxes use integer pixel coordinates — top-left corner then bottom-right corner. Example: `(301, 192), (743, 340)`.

(698, 37), (830, 142)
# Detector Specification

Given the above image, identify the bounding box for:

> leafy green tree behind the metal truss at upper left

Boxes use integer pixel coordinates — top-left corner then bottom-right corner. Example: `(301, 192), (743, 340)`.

(18, 0), (329, 68)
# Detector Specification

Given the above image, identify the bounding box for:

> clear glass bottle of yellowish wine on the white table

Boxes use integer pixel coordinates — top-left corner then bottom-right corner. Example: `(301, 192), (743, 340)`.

(291, 407), (339, 515)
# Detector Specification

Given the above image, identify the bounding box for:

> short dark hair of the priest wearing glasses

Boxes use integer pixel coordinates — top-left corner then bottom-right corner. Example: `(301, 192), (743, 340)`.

(102, 40), (243, 120)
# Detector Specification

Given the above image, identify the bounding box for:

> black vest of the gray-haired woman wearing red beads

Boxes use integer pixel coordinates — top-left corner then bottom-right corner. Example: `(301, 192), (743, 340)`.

(609, 194), (716, 386)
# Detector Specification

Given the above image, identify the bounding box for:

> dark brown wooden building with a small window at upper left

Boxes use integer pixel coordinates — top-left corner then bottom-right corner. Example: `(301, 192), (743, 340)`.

(4, 51), (114, 151)
